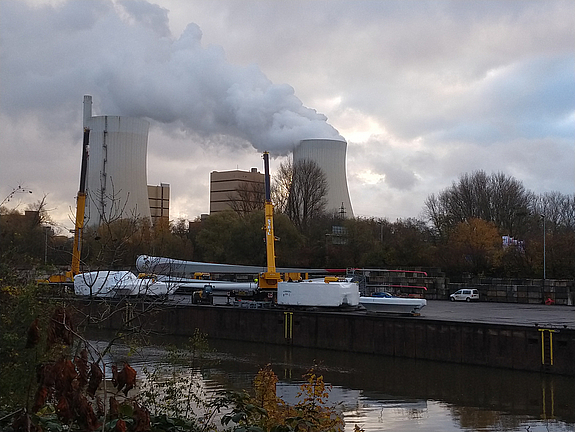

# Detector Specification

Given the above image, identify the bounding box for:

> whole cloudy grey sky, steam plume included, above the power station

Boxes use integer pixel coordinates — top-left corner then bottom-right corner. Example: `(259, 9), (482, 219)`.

(0, 0), (575, 235)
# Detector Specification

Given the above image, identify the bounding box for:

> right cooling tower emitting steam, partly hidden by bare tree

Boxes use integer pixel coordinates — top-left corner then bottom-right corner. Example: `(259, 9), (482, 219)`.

(293, 139), (353, 218)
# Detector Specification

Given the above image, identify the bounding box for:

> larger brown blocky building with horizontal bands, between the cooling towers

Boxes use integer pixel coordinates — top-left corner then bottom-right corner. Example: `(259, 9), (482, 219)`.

(210, 168), (265, 214)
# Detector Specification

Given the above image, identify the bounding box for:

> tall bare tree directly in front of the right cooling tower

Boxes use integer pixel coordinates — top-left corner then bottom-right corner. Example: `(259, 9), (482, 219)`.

(274, 159), (328, 230)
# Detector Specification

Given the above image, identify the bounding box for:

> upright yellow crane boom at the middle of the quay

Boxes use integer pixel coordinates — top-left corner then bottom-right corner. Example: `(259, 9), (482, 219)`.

(258, 152), (281, 290)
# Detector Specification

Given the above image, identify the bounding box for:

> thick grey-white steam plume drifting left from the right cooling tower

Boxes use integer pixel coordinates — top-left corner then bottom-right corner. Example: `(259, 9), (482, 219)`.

(0, 0), (341, 155)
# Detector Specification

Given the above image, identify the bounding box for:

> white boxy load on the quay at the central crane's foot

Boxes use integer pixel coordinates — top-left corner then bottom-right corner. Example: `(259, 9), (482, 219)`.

(278, 278), (359, 307)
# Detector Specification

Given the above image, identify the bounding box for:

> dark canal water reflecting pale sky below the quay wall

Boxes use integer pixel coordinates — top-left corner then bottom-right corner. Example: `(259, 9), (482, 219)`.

(92, 338), (575, 432)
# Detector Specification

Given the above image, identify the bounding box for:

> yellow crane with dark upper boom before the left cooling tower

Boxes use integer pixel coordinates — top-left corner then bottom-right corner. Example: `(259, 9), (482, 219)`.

(44, 128), (90, 283)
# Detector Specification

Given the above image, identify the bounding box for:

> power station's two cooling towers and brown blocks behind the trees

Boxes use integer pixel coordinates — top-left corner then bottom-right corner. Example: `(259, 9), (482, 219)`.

(83, 95), (353, 226)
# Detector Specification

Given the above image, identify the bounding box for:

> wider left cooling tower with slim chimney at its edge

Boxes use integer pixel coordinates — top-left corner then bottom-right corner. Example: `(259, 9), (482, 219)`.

(84, 96), (150, 226)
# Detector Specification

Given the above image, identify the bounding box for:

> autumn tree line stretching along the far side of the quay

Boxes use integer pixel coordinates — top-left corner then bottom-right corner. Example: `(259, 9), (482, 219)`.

(0, 169), (575, 280)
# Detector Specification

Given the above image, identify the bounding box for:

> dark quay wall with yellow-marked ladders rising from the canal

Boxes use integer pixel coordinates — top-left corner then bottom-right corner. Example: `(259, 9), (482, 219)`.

(78, 301), (575, 376)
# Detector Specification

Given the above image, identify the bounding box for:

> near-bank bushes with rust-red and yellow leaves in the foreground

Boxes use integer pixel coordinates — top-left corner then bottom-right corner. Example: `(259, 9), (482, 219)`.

(0, 283), (361, 432)
